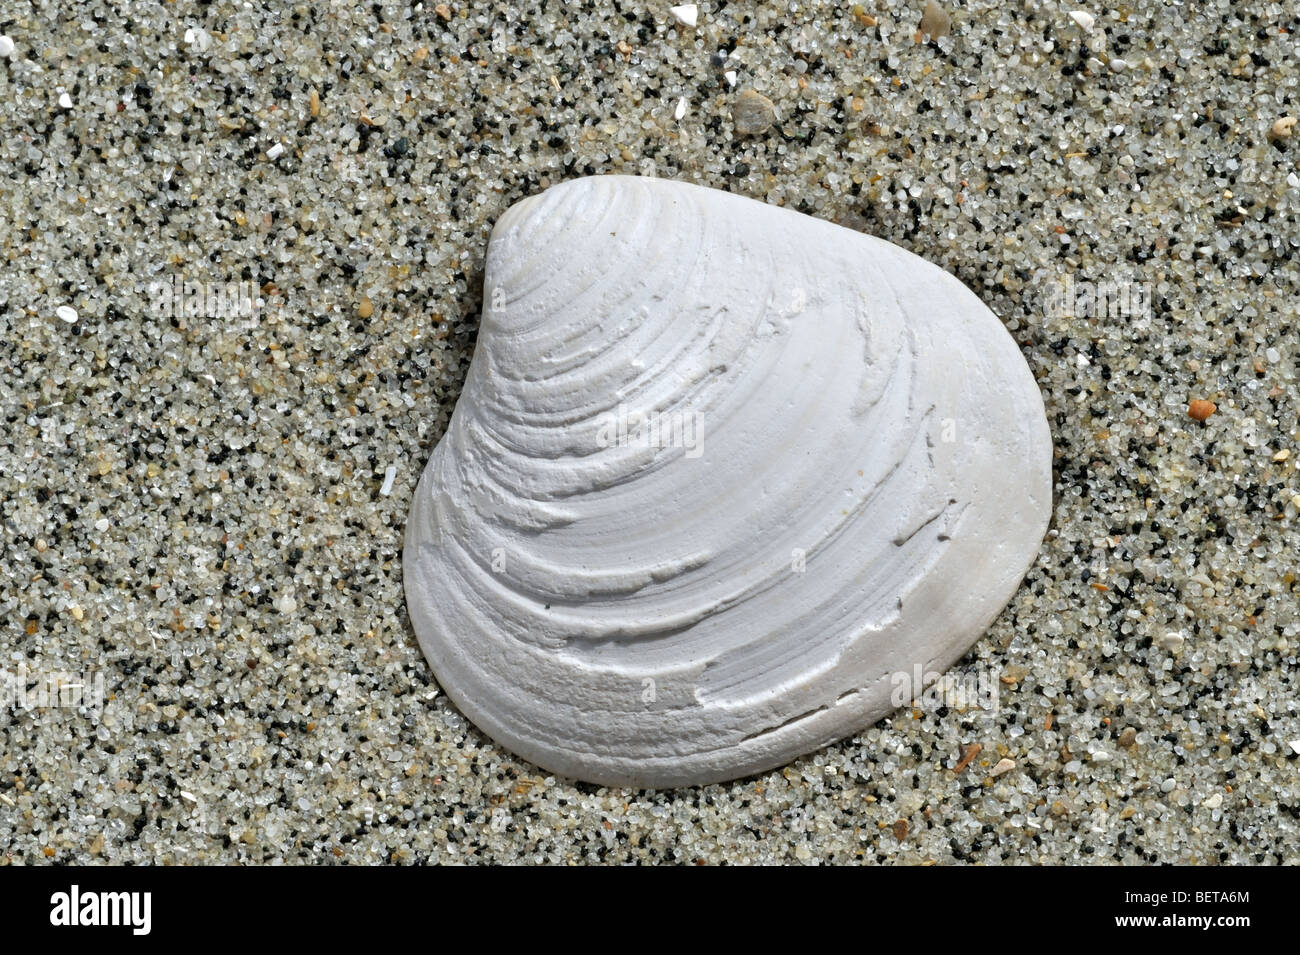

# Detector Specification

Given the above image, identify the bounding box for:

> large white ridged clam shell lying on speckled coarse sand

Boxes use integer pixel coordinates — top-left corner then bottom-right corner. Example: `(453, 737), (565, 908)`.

(404, 175), (1052, 787)
